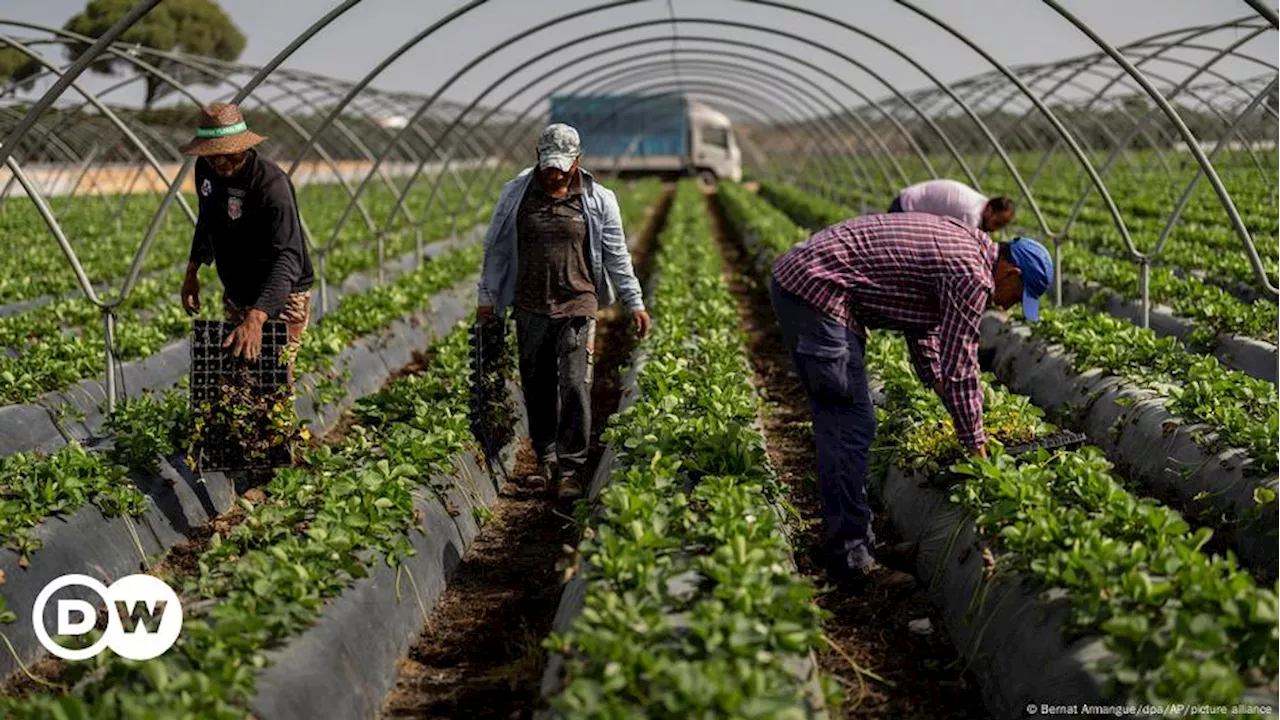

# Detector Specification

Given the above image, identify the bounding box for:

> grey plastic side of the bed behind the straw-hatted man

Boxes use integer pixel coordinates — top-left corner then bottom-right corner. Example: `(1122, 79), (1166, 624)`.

(0, 225), (484, 457)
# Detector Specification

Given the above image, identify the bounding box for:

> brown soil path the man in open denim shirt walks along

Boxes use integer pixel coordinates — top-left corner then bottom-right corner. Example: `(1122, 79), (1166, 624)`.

(383, 192), (671, 720)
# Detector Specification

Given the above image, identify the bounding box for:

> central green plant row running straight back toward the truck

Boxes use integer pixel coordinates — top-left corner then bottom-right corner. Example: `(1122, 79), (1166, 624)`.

(545, 182), (822, 719)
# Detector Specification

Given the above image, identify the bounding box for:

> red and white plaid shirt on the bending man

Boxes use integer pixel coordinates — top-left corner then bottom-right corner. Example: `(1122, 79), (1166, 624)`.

(773, 213), (997, 448)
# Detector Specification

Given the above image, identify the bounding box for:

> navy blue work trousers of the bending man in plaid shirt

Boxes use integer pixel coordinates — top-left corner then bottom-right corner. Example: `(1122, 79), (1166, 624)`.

(769, 282), (876, 568)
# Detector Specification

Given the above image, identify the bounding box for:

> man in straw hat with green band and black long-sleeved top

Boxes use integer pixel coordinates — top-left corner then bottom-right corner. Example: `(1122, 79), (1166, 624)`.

(182, 102), (315, 382)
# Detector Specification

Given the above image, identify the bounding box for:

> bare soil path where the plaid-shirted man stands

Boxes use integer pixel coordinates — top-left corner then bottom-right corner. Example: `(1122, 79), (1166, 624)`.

(707, 188), (988, 720)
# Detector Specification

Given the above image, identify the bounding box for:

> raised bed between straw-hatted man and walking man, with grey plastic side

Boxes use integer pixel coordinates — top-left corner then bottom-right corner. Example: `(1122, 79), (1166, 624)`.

(0, 320), (524, 719)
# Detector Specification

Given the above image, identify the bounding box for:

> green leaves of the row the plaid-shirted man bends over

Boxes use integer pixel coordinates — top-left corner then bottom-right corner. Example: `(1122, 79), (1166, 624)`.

(868, 333), (1280, 717)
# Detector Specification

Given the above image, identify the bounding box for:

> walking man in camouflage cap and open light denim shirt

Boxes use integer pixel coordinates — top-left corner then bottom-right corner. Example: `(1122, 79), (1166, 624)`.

(476, 123), (649, 498)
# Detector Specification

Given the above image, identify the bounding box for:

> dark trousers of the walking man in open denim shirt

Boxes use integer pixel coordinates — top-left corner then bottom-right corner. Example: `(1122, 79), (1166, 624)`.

(513, 307), (595, 477)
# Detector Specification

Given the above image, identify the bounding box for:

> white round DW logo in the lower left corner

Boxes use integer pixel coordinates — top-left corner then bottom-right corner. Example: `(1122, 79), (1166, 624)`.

(31, 574), (182, 660)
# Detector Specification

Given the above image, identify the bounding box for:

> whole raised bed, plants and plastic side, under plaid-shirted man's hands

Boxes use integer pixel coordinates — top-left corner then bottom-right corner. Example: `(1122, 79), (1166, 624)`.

(868, 333), (1280, 719)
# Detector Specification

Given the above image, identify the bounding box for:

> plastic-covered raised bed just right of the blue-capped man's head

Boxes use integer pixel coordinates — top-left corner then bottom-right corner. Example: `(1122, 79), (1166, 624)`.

(982, 306), (1280, 578)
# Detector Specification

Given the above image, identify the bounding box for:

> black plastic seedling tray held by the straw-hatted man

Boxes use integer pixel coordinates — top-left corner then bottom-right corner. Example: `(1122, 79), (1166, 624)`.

(191, 320), (293, 471)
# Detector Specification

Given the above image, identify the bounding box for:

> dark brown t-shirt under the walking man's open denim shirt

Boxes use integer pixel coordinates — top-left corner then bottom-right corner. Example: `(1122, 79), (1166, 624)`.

(515, 173), (598, 318)
